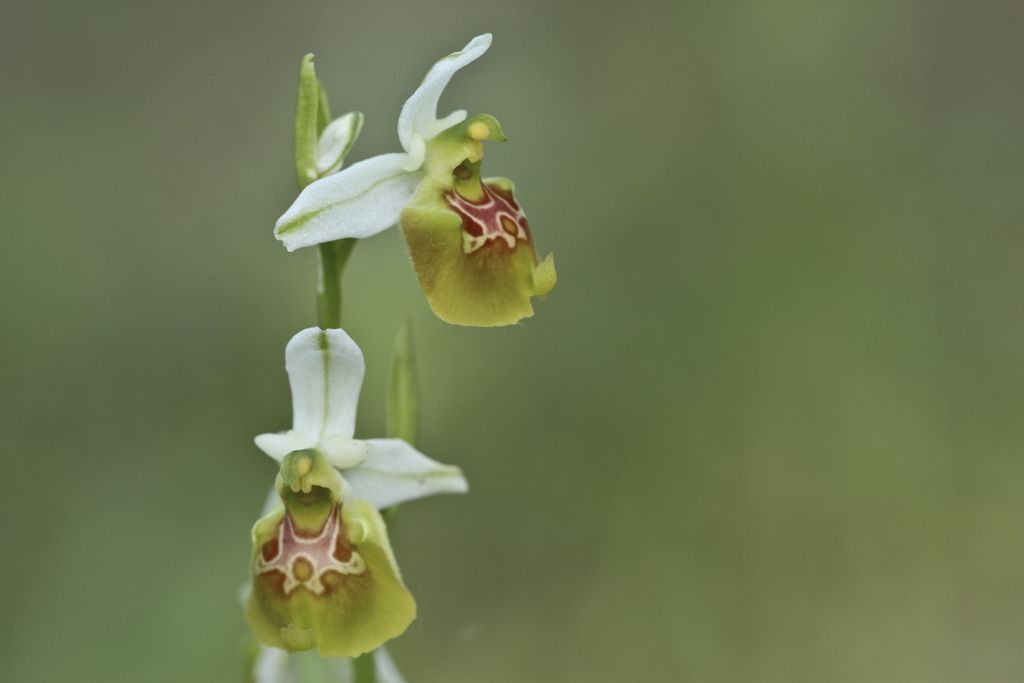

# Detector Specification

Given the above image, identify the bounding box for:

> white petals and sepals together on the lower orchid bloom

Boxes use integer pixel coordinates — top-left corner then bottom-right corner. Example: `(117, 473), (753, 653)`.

(256, 328), (468, 510)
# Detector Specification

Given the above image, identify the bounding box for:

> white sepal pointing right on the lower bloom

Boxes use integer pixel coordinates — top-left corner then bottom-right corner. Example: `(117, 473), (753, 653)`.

(345, 438), (469, 509)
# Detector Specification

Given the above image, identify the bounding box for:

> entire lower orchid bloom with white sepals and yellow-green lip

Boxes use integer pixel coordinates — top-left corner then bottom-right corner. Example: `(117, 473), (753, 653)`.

(246, 328), (468, 657)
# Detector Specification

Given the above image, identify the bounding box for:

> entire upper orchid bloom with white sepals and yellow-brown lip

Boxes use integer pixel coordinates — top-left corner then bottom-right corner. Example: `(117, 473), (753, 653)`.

(274, 34), (556, 327)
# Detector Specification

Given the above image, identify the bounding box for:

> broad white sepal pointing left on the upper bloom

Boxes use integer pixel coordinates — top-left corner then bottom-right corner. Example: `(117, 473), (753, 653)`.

(273, 154), (422, 251)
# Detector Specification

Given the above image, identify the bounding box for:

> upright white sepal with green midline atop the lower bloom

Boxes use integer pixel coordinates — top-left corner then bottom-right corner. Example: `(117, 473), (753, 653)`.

(285, 328), (366, 443)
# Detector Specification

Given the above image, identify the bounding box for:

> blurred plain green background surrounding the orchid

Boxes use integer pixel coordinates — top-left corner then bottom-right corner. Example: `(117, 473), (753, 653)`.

(0, 0), (1024, 683)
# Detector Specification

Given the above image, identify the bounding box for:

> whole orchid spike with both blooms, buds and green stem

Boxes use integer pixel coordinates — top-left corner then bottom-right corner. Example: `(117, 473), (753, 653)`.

(246, 34), (556, 683)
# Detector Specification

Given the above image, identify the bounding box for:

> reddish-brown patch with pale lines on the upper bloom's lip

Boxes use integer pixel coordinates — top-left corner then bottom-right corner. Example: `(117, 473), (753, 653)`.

(444, 183), (529, 254)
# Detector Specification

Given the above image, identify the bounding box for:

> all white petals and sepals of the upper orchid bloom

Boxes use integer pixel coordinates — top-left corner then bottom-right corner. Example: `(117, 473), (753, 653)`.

(274, 33), (490, 251)
